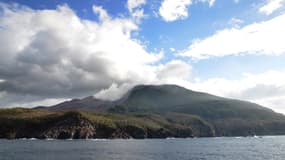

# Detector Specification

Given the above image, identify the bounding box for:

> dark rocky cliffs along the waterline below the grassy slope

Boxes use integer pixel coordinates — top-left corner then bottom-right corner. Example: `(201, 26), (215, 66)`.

(0, 112), (214, 139)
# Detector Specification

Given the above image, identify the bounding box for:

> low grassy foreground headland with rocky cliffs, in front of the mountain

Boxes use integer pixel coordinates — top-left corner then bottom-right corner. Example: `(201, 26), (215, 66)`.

(0, 109), (209, 138)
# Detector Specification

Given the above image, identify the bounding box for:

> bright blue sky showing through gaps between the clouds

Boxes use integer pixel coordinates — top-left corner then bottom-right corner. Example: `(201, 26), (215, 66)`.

(2, 0), (285, 79)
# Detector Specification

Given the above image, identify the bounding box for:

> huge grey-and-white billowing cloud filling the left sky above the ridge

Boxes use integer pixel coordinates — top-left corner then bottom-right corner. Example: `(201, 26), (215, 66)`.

(0, 4), (191, 106)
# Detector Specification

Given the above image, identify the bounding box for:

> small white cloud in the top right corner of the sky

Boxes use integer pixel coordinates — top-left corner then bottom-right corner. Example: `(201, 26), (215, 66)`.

(259, 0), (285, 15)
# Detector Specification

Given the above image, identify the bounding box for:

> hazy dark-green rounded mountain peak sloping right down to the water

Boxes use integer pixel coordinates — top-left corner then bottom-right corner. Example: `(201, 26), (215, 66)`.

(110, 85), (285, 136)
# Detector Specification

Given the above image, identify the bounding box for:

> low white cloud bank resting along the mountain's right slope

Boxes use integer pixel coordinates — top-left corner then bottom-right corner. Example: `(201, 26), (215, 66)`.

(184, 71), (285, 113)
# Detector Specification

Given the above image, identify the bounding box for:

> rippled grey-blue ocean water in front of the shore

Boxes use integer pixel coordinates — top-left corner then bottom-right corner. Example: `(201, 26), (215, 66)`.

(0, 136), (285, 160)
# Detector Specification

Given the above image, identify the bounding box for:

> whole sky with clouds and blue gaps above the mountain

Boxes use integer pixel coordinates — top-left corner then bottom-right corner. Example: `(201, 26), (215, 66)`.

(0, 0), (285, 113)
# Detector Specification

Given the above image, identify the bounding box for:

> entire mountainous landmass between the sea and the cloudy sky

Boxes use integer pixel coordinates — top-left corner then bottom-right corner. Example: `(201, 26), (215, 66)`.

(0, 85), (285, 138)
